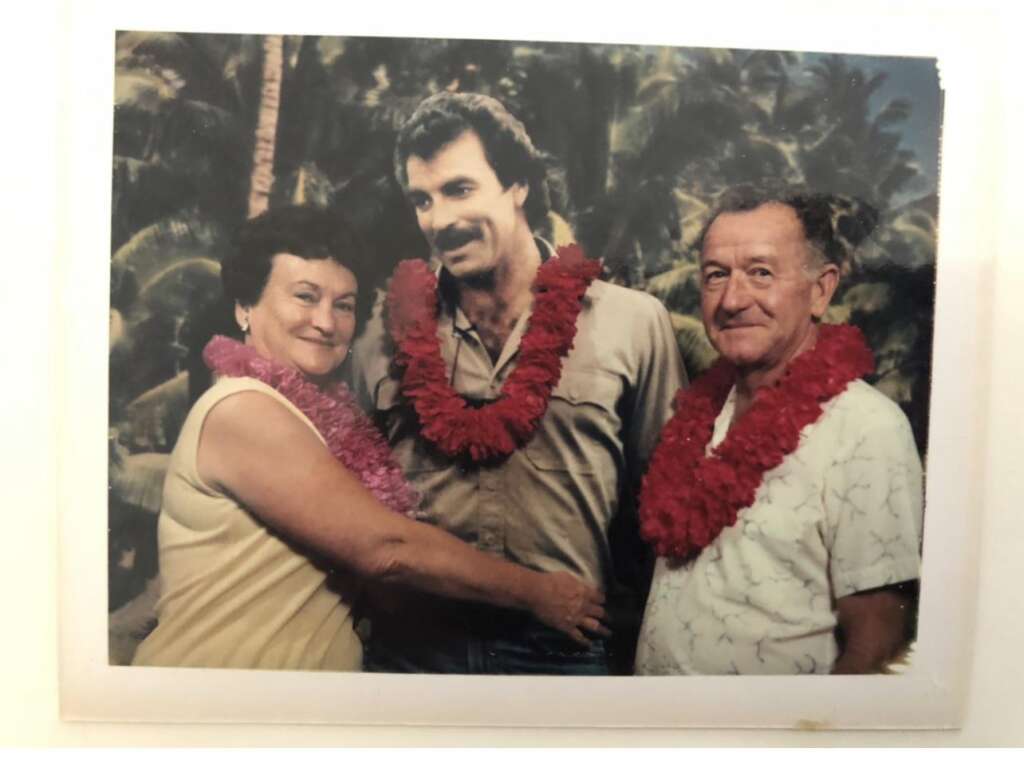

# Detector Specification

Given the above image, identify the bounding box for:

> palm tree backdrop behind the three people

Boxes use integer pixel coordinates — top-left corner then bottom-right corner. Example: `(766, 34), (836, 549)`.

(108, 32), (941, 664)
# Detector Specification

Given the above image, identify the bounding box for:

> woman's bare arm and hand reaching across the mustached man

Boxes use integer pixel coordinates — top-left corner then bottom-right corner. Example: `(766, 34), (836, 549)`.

(197, 391), (606, 643)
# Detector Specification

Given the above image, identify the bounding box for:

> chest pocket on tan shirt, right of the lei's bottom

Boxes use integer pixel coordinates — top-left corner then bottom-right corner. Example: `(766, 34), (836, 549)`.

(523, 370), (623, 474)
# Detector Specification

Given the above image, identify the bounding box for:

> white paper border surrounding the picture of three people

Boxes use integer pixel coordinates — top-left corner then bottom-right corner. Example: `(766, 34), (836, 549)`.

(57, 0), (1000, 728)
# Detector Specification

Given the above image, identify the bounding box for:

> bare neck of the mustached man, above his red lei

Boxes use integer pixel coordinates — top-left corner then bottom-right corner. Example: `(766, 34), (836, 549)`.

(456, 228), (541, 324)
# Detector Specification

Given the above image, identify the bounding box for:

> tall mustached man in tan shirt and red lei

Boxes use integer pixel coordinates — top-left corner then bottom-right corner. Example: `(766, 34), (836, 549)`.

(354, 92), (683, 674)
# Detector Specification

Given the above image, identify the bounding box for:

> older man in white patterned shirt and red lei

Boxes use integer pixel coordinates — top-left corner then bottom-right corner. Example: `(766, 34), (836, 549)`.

(636, 187), (923, 674)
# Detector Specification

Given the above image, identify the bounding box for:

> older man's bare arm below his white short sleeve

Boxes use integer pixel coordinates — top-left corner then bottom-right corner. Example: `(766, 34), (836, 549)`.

(833, 586), (910, 675)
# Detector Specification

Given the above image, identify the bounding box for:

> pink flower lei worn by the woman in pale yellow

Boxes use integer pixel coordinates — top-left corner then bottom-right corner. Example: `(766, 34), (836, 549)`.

(203, 335), (420, 513)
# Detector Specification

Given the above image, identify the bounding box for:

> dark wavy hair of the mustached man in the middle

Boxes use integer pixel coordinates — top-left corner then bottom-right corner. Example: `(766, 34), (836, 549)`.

(394, 91), (551, 229)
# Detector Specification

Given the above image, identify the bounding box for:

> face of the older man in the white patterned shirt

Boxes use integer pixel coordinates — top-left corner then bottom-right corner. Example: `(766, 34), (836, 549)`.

(700, 203), (839, 371)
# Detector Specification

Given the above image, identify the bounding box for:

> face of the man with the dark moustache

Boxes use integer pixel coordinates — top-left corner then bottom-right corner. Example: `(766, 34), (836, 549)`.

(406, 130), (529, 278)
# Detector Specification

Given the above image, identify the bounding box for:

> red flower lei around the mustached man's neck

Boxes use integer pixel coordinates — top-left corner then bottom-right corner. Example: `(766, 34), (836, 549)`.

(387, 246), (601, 462)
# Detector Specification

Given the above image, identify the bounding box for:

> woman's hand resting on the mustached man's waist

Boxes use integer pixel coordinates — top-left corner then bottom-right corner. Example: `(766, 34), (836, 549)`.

(529, 573), (611, 646)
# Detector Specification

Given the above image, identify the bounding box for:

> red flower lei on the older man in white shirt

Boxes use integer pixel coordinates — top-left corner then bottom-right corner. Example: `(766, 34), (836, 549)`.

(640, 325), (874, 559)
